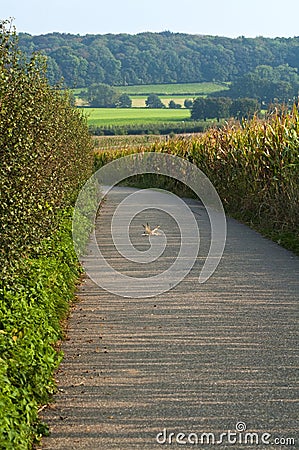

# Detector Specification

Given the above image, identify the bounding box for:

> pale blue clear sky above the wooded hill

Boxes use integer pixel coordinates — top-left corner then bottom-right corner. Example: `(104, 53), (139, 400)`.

(0, 0), (299, 37)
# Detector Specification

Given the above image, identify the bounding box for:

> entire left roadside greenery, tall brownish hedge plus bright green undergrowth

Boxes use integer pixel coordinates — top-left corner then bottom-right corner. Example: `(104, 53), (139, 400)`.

(0, 21), (93, 450)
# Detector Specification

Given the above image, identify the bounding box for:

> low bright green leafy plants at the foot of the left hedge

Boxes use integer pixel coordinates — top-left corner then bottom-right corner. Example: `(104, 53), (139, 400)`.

(0, 214), (80, 450)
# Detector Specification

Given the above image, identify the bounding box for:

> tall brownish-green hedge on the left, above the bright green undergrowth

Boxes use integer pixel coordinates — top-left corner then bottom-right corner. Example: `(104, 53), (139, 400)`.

(0, 23), (92, 283)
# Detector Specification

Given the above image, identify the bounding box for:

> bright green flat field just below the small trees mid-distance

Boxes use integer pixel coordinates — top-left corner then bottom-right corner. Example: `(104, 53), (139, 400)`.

(84, 108), (190, 126)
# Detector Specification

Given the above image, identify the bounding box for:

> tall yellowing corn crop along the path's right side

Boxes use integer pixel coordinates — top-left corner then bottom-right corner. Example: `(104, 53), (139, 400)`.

(95, 108), (299, 253)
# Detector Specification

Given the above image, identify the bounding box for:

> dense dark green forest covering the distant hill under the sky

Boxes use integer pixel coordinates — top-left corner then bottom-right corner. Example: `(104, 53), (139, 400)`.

(19, 31), (299, 88)
